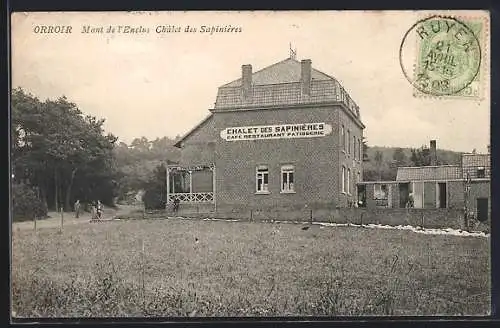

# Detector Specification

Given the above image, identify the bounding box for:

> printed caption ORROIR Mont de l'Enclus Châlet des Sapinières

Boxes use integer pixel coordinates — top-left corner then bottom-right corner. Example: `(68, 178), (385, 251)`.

(33, 25), (243, 35)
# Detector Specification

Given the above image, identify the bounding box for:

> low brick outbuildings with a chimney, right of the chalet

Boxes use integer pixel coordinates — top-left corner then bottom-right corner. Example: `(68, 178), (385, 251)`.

(358, 140), (491, 220)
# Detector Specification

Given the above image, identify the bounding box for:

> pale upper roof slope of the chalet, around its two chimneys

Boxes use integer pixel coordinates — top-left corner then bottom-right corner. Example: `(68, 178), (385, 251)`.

(221, 58), (335, 88)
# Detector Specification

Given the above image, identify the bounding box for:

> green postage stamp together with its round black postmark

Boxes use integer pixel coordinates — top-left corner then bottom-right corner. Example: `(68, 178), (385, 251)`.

(400, 15), (488, 99)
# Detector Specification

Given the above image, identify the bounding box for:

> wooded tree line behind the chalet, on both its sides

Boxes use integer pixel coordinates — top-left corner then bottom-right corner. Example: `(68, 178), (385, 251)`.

(11, 88), (460, 217)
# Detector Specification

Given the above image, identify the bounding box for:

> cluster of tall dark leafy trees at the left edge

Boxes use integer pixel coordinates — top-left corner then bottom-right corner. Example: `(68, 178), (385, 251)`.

(11, 88), (117, 219)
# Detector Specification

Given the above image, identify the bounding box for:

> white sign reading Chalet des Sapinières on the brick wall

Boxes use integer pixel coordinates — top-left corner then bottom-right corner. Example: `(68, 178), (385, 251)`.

(220, 123), (332, 141)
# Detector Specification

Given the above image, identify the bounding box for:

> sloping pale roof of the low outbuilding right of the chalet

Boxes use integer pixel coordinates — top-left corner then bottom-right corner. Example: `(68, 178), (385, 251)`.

(396, 165), (462, 181)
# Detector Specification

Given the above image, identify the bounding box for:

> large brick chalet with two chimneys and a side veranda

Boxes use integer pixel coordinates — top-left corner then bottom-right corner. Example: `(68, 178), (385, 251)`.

(167, 58), (364, 210)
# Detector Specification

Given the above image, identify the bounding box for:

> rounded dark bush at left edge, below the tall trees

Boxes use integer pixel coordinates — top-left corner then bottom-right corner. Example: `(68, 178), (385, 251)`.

(12, 183), (47, 221)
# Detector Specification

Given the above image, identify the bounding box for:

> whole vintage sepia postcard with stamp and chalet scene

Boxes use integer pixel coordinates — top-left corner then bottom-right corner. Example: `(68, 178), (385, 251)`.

(10, 11), (491, 320)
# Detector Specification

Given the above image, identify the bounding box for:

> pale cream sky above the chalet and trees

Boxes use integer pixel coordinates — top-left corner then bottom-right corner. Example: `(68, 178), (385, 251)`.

(11, 11), (490, 152)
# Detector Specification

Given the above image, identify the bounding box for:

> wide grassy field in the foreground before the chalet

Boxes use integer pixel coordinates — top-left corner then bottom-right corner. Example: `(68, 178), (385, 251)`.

(12, 219), (490, 317)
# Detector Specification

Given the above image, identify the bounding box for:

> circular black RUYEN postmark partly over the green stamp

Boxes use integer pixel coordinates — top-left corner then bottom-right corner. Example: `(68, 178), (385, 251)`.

(399, 16), (481, 96)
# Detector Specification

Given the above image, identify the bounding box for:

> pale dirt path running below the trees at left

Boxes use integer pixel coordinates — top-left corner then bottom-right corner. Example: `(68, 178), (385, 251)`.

(12, 205), (141, 230)
